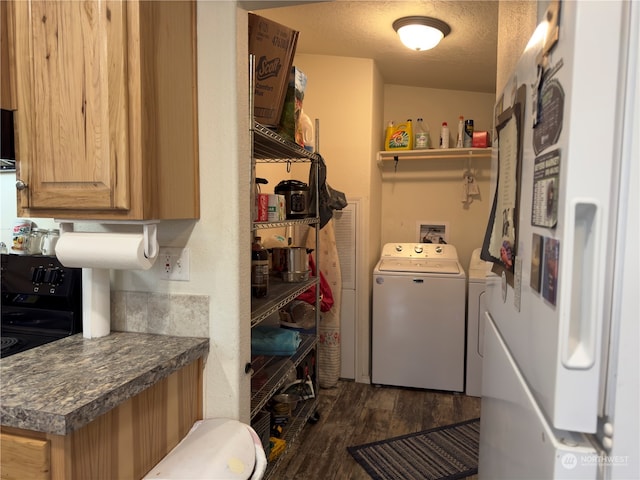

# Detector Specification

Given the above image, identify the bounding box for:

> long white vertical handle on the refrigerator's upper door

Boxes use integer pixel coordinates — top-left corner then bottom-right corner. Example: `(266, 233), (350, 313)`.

(560, 199), (603, 370)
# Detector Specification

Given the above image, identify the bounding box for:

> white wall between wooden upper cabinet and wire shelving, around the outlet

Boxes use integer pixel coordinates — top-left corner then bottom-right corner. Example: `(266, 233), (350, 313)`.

(112, 1), (251, 421)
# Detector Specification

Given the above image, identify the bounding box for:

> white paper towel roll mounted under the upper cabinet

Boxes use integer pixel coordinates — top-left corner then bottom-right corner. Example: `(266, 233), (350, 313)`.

(56, 232), (158, 270)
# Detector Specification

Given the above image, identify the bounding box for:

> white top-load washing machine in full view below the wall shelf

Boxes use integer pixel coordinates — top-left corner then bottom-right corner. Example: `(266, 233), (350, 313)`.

(371, 243), (466, 392)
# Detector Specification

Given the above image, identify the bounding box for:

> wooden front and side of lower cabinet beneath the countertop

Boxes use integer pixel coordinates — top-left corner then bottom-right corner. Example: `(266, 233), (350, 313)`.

(0, 360), (202, 480)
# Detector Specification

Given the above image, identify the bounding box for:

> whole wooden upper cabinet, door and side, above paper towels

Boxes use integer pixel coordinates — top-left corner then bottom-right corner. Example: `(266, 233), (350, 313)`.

(12, 0), (199, 220)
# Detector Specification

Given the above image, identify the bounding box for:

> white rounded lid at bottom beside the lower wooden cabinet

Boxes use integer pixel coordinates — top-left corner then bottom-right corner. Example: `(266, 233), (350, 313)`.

(144, 418), (267, 480)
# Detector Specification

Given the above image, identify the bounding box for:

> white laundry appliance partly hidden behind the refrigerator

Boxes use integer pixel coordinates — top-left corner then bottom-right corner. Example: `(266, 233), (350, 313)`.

(465, 248), (492, 397)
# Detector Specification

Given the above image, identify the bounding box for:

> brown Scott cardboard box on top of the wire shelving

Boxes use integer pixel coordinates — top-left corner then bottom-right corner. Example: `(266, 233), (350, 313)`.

(249, 13), (299, 127)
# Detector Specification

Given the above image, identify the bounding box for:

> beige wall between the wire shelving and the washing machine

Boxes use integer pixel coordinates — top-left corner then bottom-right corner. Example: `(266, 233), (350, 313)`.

(286, 54), (383, 382)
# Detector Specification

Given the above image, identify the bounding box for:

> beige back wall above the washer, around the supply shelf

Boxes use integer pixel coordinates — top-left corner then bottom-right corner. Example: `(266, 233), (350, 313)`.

(376, 85), (495, 271)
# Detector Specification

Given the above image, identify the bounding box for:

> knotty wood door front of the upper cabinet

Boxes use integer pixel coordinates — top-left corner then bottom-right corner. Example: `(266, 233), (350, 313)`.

(13, 1), (130, 212)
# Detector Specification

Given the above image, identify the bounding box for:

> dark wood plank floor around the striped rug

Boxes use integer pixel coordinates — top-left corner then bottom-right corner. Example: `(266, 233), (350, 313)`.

(269, 381), (480, 480)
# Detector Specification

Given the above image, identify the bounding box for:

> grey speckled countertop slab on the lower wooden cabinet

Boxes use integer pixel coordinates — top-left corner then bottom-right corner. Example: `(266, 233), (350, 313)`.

(0, 332), (209, 435)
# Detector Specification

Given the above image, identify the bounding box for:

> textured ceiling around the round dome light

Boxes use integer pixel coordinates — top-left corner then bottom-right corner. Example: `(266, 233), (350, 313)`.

(252, 0), (498, 93)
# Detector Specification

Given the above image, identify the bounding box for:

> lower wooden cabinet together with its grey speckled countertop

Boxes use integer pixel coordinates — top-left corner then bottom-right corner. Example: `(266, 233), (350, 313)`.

(0, 332), (208, 480)
